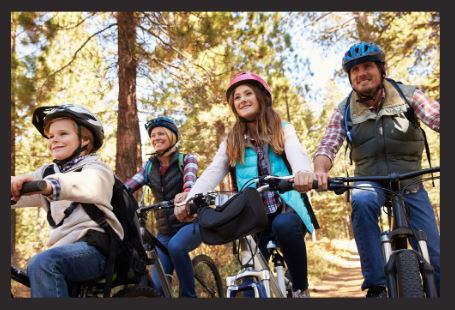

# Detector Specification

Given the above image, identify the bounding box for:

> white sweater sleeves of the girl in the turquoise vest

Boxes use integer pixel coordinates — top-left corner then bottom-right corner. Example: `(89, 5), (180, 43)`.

(187, 123), (313, 199)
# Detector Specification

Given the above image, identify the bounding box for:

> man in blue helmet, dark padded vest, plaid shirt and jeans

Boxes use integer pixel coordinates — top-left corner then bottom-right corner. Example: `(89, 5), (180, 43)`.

(313, 42), (440, 297)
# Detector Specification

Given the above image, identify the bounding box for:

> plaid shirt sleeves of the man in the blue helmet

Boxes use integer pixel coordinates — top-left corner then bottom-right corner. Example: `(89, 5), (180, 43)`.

(313, 89), (440, 162)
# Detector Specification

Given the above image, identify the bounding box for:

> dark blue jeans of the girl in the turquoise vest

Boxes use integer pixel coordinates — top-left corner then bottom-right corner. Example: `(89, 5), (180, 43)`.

(259, 212), (308, 291)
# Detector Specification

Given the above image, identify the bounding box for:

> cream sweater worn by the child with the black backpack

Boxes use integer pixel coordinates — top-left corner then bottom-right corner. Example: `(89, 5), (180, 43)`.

(12, 155), (123, 247)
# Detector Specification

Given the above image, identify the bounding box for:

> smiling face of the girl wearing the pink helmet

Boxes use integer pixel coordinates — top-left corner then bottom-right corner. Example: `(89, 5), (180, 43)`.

(234, 84), (260, 120)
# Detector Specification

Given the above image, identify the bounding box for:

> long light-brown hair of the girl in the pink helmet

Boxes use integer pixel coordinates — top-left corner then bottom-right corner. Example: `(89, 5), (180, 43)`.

(226, 83), (284, 167)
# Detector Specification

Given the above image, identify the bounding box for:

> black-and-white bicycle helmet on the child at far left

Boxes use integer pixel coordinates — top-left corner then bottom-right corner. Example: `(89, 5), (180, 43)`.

(32, 104), (104, 151)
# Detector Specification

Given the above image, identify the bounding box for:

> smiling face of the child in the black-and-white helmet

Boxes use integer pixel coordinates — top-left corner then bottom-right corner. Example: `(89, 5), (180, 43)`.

(47, 119), (89, 160)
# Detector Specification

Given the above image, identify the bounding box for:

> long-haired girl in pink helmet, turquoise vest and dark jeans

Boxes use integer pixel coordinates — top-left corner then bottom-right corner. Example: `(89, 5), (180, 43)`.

(174, 72), (314, 297)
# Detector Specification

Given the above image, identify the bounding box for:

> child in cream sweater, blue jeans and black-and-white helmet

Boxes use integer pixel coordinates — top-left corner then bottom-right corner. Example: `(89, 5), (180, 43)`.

(11, 104), (124, 297)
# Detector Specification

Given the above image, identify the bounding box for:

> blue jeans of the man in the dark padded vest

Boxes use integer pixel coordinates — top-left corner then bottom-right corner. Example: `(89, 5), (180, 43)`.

(351, 182), (440, 291)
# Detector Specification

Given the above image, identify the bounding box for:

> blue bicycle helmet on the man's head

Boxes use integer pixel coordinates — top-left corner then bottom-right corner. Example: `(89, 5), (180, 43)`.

(342, 42), (385, 73)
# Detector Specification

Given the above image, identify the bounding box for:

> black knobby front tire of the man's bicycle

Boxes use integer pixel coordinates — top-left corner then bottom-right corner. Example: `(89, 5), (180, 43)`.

(395, 251), (425, 298)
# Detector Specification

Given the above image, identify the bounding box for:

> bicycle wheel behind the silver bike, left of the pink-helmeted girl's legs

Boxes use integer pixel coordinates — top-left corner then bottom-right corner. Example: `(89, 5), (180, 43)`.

(192, 254), (224, 298)
